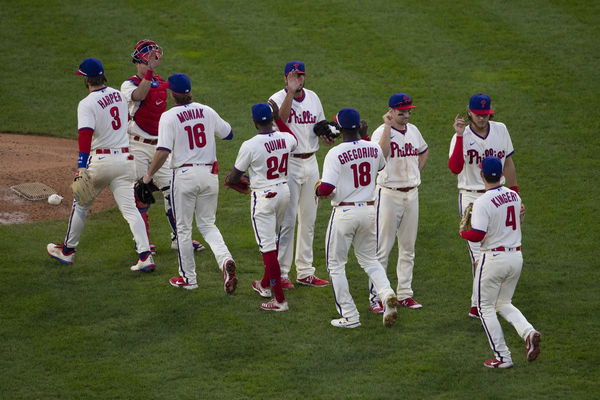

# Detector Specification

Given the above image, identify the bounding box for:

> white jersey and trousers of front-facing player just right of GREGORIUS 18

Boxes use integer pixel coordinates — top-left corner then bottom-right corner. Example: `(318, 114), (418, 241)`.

(369, 123), (428, 303)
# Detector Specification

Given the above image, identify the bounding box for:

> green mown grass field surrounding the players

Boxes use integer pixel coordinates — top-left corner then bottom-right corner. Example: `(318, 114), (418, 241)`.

(0, 0), (600, 399)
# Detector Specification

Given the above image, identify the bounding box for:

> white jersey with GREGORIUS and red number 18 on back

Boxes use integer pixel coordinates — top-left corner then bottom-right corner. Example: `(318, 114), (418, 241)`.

(322, 140), (385, 206)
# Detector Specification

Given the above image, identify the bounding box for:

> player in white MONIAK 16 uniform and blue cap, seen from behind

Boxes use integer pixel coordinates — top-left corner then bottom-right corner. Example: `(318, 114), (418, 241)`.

(143, 74), (237, 294)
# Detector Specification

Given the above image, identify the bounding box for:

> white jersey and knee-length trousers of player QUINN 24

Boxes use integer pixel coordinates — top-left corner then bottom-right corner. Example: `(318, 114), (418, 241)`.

(234, 131), (298, 253)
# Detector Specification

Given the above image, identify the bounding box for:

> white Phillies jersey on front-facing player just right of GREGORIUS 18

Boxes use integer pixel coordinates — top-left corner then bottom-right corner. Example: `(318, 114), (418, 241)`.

(371, 123), (428, 188)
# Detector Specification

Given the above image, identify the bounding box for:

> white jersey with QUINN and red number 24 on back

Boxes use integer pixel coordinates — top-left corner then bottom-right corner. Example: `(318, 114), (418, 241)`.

(234, 131), (298, 189)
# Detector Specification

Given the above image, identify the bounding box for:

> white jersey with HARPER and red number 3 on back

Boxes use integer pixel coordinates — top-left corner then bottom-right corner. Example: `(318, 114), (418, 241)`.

(77, 87), (129, 150)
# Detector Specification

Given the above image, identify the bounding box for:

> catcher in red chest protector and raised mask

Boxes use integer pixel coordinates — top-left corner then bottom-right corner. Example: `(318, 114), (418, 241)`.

(121, 39), (205, 253)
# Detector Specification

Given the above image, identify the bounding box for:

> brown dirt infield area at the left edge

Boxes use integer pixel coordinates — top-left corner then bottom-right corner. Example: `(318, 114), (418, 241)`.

(0, 133), (116, 225)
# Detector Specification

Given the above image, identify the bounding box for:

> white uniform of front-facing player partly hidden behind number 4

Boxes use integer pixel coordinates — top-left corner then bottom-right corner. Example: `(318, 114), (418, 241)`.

(450, 121), (514, 307)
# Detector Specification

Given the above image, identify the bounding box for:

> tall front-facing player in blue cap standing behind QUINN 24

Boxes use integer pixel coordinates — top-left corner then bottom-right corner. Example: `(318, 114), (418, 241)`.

(269, 61), (329, 289)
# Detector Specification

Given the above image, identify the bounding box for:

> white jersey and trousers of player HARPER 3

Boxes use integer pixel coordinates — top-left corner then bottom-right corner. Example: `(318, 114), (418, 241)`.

(64, 87), (150, 253)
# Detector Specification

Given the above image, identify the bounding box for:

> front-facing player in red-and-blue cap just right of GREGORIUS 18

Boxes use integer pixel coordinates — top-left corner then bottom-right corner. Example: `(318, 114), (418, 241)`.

(369, 93), (429, 313)
